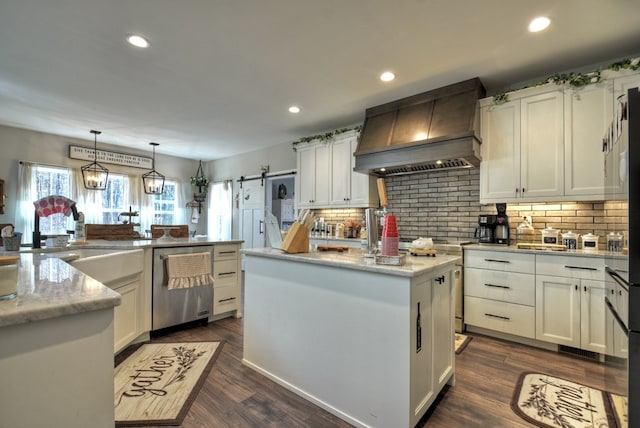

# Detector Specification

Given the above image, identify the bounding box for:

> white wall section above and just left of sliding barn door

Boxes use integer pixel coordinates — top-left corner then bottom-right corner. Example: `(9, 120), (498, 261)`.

(206, 143), (297, 239)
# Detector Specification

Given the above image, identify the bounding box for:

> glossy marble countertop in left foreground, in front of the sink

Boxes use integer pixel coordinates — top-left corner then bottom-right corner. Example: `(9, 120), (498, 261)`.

(0, 252), (120, 327)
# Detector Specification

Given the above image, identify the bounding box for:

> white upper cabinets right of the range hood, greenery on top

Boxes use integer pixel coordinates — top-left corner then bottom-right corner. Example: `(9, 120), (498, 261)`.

(480, 73), (640, 203)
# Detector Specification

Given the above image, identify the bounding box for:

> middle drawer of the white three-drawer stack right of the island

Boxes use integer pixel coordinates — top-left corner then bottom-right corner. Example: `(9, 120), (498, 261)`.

(464, 268), (536, 306)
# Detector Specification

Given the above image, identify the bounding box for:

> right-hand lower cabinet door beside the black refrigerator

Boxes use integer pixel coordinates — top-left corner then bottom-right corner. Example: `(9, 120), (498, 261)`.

(580, 279), (612, 354)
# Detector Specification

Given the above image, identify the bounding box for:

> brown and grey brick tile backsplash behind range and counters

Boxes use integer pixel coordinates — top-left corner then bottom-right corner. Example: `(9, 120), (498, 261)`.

(316, 168), (627, 249)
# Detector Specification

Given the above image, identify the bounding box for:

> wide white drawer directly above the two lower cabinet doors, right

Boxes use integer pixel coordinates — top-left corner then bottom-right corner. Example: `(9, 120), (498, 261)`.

(536, 255), (605, 281)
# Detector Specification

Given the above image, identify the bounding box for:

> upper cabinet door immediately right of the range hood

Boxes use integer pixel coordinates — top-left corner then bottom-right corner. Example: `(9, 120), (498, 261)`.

(480, 100), (520, 203)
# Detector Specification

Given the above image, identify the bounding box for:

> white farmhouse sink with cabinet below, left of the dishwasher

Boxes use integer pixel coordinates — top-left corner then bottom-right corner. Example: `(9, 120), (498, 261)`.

(70, 250), (146, 353)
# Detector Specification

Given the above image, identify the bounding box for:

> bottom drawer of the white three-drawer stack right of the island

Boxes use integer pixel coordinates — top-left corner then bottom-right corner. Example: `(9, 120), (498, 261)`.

(464, 296), (536, 339)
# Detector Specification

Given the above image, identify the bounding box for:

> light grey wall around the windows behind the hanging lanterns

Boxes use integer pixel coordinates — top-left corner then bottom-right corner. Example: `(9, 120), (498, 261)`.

(0, 126), (206, 233)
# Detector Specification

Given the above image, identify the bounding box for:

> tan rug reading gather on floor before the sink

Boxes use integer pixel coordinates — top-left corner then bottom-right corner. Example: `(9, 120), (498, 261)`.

(115, 341), (223, 427)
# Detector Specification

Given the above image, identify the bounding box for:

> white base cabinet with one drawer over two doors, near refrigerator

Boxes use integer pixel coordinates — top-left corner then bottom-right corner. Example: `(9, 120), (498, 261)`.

(536, 255), (611, 353)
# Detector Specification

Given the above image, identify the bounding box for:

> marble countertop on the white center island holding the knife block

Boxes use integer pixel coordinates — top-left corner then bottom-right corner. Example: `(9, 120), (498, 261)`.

(242, 248), (462, 277)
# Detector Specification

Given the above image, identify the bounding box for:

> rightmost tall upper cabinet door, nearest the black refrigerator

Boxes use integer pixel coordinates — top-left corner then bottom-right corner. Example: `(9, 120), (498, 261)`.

(564, 82), (613, 199)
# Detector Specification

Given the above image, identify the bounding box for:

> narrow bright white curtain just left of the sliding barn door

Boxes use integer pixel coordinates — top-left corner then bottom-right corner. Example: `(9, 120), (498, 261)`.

(207, 180), (233, 241)
